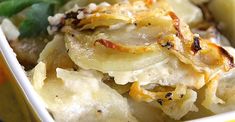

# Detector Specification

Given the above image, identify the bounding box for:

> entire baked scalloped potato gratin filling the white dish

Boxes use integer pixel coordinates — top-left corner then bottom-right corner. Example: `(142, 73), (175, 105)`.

(2, 0), (235, 122)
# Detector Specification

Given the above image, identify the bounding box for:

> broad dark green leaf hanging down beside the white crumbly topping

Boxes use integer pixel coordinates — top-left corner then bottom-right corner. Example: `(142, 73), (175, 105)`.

(19, 3), (53, 37)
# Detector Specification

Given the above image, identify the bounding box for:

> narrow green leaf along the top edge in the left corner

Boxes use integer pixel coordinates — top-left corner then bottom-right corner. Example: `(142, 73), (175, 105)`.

(0, 0), (60, 17)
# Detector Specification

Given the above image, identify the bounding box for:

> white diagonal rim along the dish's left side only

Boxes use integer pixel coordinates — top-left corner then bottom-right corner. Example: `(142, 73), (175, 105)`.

(0, 25), (54, 122)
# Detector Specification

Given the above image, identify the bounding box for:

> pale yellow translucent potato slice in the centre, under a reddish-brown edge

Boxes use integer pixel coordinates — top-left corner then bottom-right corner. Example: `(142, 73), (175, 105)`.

(65, 27), (167, 72)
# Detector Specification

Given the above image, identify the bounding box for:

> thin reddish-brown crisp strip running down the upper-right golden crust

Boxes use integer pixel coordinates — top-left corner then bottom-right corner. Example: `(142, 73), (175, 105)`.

(168, 11), (184, 39)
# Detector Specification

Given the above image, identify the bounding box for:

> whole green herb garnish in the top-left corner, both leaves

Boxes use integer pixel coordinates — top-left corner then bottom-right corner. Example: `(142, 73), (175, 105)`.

(0, 0), (66, 37)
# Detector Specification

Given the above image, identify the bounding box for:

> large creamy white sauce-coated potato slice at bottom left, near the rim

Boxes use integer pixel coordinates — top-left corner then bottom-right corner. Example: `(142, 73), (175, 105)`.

(49, 68), (137, 122)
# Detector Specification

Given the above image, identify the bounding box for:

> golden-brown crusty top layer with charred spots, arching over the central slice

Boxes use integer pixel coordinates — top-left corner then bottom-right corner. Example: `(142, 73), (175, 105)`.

(59, 0), (234, 77)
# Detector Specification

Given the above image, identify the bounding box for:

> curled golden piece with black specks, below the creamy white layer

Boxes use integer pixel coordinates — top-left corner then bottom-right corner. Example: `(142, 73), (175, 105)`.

(129, 82), (198, 120)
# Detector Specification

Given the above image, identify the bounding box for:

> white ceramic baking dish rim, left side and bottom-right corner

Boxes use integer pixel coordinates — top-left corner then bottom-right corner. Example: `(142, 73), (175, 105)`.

(0, 27), (235, 122)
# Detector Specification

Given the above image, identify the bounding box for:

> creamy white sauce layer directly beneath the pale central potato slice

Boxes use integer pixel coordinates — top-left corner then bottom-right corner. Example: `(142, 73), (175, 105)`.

(108, 56), (205, 88)
